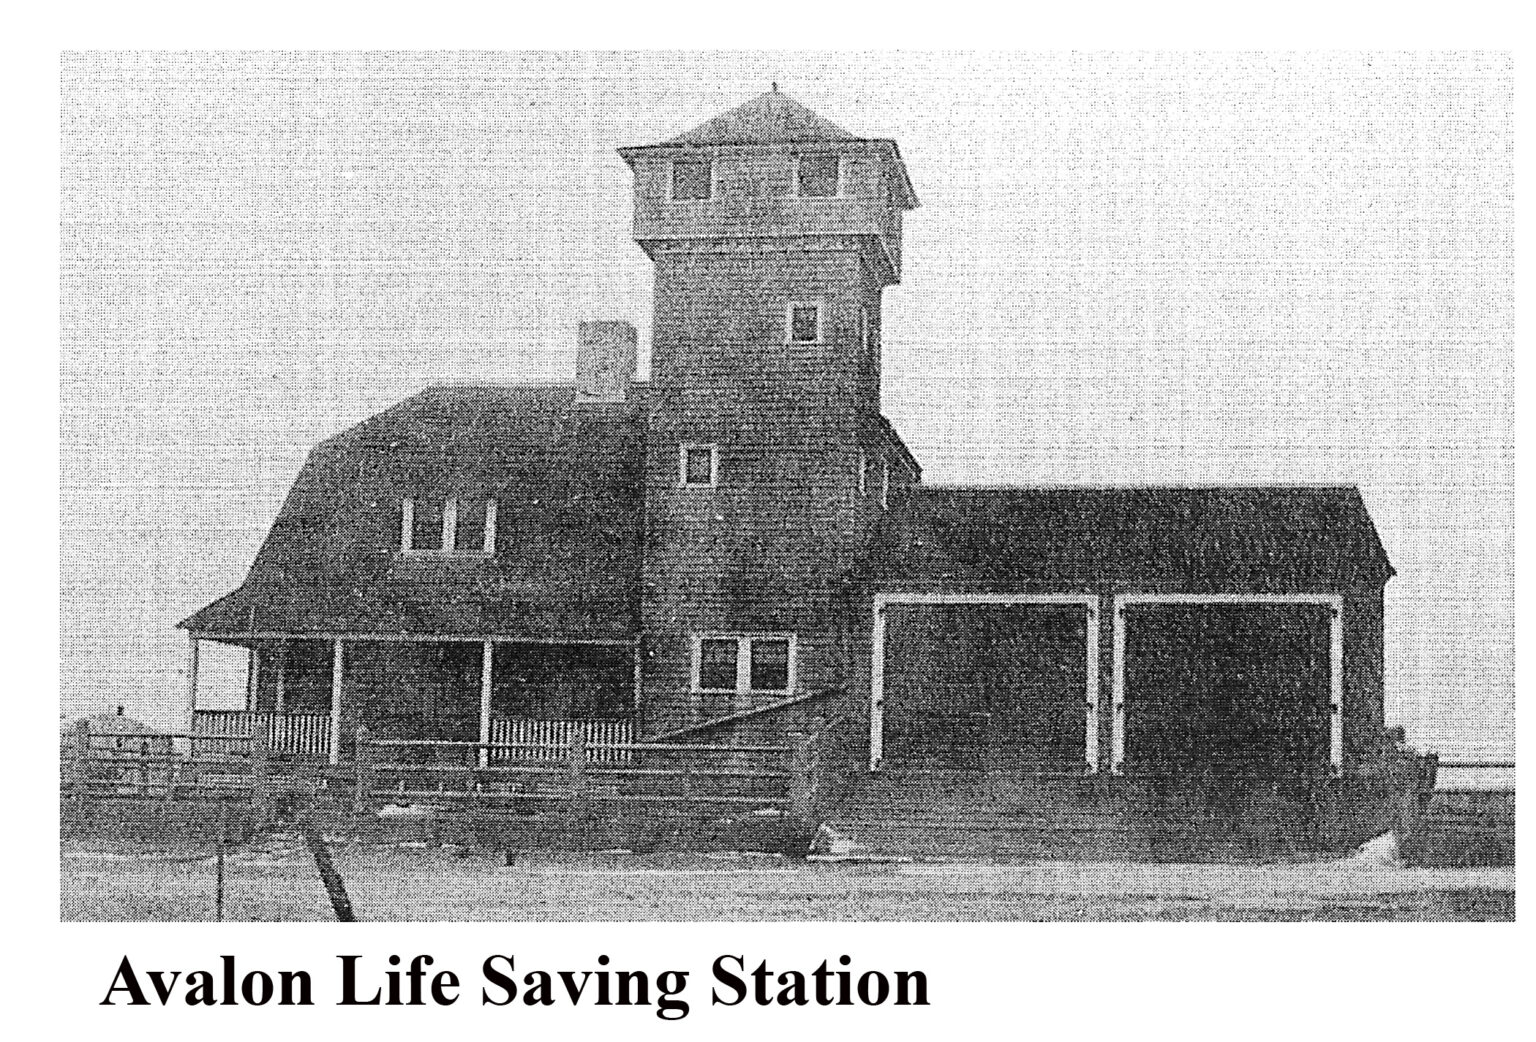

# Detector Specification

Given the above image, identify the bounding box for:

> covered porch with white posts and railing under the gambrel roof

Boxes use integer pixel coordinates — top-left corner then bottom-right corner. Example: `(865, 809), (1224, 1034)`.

(187, 632), (636, 764)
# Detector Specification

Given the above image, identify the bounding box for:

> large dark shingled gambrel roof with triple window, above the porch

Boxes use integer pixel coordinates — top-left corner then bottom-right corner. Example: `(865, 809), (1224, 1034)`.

(181, 384), (644, 641)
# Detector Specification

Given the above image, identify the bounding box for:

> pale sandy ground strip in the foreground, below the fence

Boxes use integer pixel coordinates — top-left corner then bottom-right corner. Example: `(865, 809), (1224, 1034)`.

(60, 836), (1514, 922)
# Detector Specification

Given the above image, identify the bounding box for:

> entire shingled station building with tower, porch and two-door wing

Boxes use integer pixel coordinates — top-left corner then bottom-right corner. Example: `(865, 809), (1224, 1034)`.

(183, 91), (1392, 842)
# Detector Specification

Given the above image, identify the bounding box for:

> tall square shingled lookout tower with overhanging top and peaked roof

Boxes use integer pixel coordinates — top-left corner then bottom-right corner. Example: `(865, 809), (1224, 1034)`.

(619, 91), (917, 732)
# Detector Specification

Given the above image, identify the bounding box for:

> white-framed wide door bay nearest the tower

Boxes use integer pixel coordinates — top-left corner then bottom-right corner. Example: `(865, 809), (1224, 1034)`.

(871, 601), (1097, 775)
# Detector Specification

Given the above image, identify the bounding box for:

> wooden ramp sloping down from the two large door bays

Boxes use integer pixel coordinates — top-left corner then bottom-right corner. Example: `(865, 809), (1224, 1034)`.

(825, 768), (1318, 861)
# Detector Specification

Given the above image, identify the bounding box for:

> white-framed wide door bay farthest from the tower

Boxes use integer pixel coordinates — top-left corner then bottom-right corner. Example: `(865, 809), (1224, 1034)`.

(1115, 598), (1341, 788)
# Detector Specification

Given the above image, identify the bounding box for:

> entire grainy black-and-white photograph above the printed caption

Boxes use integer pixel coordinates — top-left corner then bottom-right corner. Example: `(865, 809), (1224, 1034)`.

(58, 51), (1514, 928)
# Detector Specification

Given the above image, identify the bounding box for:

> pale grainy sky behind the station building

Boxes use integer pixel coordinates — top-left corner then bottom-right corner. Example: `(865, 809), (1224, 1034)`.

(60, 52), (1514, 771)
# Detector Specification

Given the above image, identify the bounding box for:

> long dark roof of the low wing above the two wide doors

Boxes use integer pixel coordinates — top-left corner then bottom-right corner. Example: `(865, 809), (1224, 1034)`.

(860, 486), (1392, 592)
